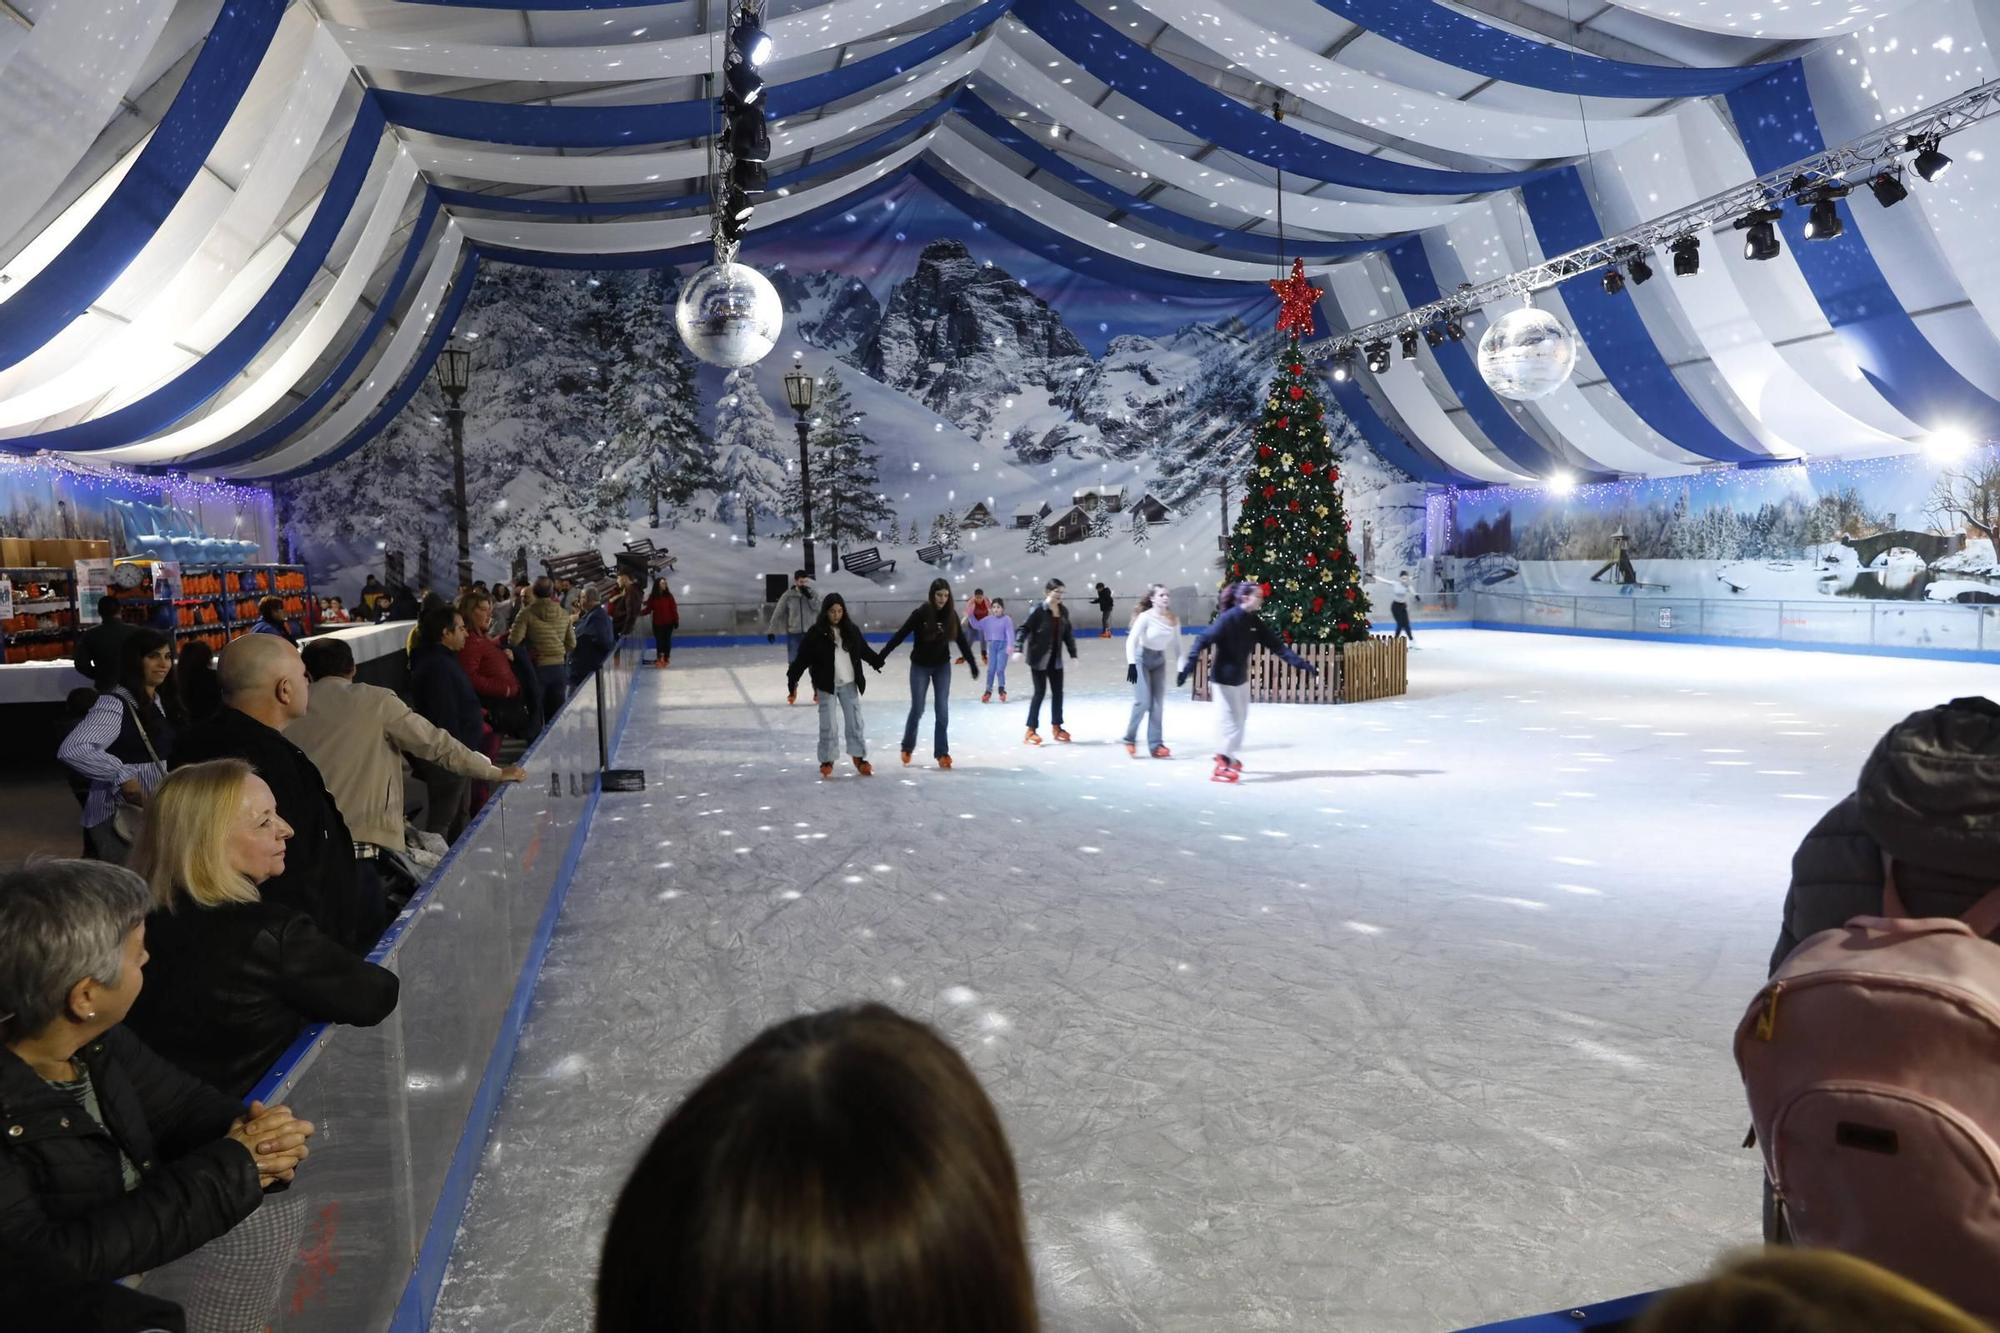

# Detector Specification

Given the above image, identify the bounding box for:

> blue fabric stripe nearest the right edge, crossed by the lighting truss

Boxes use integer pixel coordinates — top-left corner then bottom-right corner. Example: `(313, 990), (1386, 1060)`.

(1730, 60), (2000, 436)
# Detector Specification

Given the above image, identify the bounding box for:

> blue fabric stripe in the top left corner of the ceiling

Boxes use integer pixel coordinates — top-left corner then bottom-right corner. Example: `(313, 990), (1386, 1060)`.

(0, 0), (286, 370)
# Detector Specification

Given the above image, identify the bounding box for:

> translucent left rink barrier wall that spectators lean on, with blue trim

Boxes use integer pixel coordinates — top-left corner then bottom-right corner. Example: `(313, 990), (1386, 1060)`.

(237, 646), (638, 1333)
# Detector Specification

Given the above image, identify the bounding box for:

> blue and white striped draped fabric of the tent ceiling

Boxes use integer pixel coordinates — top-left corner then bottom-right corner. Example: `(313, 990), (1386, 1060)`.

(0, 0), (2000, 480)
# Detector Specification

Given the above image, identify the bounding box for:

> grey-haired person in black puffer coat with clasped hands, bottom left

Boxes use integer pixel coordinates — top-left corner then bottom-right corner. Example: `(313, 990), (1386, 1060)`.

(0, 861), (312, 1281)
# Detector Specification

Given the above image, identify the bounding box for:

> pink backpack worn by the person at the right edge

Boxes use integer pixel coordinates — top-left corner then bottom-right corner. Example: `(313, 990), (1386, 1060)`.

(1736, 857), (2000, 1319)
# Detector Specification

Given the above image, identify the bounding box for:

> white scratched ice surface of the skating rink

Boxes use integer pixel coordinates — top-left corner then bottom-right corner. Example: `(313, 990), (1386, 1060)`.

(436, 630), (1996, 1333)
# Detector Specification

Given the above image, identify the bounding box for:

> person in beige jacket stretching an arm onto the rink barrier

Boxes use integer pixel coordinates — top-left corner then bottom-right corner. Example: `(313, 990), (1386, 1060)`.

(284, 638), (528, 904)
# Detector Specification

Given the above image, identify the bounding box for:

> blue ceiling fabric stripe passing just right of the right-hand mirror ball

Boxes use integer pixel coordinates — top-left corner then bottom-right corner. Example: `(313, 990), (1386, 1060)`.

(1522, 166), (1768, 462)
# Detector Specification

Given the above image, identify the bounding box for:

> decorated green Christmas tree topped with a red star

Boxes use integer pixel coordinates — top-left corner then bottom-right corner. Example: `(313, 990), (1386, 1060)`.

(1228, 260), (1368, 642)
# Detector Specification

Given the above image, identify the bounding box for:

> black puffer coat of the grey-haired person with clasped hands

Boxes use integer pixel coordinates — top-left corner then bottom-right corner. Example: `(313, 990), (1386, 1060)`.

(0, 1027), (264, 1279)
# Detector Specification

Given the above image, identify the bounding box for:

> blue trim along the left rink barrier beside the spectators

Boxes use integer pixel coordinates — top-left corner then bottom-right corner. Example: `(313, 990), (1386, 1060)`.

(388, 660), (638, 1333)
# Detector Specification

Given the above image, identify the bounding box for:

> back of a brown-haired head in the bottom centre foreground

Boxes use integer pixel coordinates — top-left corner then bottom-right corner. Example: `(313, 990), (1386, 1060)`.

(596, 1000), (1038, 1333)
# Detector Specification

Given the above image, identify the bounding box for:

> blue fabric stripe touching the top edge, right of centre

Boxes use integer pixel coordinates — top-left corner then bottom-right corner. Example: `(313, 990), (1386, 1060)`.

(1320, 0), (1778, 98)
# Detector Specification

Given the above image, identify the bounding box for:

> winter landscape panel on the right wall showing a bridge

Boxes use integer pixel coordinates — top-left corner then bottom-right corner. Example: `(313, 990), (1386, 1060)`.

(1432, 448), (2000, 604)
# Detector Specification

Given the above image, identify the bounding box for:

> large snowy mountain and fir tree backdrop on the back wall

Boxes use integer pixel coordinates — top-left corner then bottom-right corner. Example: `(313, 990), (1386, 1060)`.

(278, 180), (1426, 604)
